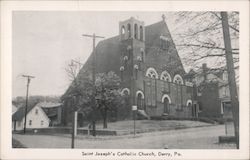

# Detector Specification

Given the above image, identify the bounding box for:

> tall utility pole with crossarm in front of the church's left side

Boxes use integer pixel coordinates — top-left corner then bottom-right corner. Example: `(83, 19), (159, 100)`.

(82, 33), (105, 136)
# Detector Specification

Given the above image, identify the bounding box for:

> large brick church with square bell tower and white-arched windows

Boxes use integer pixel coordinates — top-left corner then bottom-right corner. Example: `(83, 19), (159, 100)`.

(62, 16), (201, 124)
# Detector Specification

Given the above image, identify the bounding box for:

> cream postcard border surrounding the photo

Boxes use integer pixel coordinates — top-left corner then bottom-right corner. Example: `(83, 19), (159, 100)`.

(0, 0), (249, 160)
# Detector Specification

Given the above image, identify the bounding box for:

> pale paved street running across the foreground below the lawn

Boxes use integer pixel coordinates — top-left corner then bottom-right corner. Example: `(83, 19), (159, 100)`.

(13, 125), (236, 149)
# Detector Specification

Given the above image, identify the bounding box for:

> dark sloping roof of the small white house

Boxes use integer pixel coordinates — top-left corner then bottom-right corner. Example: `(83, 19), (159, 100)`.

(12, 102), (38, 121)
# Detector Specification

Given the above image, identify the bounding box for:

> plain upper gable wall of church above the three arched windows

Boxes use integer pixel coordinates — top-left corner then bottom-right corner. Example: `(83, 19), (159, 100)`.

(145, 20), (185, 76)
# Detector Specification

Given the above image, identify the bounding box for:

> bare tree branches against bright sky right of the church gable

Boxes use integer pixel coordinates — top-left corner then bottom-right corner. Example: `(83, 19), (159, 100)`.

(174, 12), (239, 68)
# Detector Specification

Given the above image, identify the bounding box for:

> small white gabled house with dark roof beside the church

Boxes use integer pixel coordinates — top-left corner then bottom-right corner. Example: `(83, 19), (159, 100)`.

(12, 103), (50, 131)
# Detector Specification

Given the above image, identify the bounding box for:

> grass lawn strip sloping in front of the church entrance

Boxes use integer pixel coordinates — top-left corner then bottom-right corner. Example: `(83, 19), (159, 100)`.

(93, 120), (213, 134)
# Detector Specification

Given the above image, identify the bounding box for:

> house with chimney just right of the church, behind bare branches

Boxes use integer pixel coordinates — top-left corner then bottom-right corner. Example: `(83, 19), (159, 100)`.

(187, 64), (238, 118)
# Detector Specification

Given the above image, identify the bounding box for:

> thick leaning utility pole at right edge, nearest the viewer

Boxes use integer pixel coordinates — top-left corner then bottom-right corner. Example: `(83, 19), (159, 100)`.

(221, 12), (239, 149)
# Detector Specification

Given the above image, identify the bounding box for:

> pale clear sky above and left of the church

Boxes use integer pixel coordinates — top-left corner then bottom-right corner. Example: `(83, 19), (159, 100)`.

(12, 11), (180, 97)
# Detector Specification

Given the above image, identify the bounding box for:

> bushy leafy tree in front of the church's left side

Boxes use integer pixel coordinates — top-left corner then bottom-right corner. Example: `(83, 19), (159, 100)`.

(63, 59), (122, 128)
